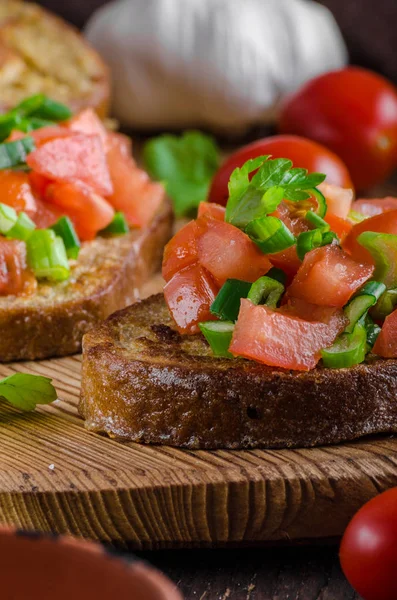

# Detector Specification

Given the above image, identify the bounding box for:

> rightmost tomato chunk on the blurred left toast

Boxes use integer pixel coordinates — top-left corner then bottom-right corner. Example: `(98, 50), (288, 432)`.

(107, 137), (164, 227)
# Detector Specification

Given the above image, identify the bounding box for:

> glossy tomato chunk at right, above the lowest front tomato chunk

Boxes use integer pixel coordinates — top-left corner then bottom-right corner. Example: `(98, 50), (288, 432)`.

(288, 245), (374, 307)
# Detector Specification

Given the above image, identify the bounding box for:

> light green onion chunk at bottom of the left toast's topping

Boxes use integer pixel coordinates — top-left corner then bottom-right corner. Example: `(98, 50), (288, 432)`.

(26, 229), (70, 281)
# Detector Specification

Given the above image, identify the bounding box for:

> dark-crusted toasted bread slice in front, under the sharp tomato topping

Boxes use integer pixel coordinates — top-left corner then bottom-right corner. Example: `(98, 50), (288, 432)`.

(80, 295), (397, 449)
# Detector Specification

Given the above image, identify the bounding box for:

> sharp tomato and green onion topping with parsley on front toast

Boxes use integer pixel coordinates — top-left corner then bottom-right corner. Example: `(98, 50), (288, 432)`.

(163, 156), (397, 371)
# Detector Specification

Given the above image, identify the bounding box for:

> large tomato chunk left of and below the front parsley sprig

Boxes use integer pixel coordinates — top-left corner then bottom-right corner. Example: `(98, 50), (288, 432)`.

(197, 217), (272, 286)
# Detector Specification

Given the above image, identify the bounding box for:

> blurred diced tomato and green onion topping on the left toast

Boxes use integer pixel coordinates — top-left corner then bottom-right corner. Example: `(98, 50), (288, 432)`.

(0, 94), (163, 296)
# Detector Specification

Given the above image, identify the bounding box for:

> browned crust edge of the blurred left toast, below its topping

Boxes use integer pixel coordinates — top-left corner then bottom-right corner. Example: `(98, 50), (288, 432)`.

(0, 200), (173, 362)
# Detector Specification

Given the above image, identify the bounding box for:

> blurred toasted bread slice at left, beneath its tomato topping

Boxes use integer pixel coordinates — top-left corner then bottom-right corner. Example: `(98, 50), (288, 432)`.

(0, 200), (173, 362)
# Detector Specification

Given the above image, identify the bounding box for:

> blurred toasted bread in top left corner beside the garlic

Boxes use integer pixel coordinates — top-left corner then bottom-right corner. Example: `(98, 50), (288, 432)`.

(0, 0), (110, 117)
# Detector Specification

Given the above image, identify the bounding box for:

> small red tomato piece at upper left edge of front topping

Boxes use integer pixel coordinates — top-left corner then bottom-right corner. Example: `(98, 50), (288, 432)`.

(163, 221), (198, 281)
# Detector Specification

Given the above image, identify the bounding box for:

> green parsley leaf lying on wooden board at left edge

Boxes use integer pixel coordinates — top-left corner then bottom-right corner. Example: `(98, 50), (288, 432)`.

(0, 373), (57, 411)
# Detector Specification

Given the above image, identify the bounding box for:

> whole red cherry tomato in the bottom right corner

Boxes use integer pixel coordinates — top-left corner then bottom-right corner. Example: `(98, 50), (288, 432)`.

(340, 488), (397, 600)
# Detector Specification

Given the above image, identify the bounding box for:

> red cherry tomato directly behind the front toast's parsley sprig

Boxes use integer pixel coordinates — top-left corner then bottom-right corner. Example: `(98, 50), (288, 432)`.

(208, 135), (353, 205)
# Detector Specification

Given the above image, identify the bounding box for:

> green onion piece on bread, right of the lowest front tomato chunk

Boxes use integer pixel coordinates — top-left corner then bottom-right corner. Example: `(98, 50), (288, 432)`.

(321, 323), (367, 369)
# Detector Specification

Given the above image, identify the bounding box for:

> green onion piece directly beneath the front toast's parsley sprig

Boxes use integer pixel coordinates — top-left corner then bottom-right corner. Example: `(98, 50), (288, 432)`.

(245, 217), (296, 254)
